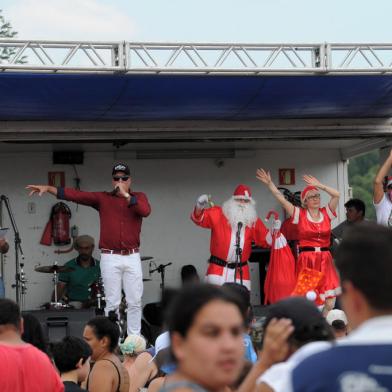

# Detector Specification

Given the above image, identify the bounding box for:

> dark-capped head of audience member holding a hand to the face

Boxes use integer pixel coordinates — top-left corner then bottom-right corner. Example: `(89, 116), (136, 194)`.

(264, 297), (334, 348)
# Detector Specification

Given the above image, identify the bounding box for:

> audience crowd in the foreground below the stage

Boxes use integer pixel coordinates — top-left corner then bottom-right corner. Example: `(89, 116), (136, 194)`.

(0, 223), (392, 392)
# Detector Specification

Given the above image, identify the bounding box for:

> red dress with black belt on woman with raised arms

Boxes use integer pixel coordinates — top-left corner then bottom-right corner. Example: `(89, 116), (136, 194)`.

(291, 205), (340, 301)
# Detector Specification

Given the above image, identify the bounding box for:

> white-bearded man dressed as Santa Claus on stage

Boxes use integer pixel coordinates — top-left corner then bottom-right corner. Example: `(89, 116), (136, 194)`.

(191, 184), (271, 290)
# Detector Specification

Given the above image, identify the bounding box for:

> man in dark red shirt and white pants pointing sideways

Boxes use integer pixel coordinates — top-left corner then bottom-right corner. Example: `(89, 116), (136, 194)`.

(27, 163), (151, 334)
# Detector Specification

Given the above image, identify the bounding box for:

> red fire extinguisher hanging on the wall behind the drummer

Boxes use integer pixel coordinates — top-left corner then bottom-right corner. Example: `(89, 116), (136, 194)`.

(40, 202), (72, 246)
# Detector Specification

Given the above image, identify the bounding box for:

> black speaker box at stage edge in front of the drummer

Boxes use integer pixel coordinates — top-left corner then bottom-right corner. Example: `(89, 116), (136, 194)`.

(23, 309), (95, 343)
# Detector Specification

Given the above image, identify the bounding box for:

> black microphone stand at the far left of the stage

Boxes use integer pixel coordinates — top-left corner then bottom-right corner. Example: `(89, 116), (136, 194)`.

(0, 195), (26, 309)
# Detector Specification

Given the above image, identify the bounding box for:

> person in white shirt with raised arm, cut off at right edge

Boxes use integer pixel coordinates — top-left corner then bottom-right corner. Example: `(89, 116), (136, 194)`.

(373, 150), (392, 227)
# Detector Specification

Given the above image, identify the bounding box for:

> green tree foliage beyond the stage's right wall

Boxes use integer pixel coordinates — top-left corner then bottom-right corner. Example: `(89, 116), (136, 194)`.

(348, 150), (380, 220)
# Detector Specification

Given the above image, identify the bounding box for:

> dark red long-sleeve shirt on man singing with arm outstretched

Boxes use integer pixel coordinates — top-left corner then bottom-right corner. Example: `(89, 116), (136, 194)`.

(57, 188), (151, 250)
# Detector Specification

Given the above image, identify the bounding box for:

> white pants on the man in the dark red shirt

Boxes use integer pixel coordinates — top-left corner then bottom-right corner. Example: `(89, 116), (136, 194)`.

(100, 253), (143, 335)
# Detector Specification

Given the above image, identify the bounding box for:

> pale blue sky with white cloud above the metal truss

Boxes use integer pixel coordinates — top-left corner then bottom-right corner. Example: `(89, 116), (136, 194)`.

(0, 0), (392, 43)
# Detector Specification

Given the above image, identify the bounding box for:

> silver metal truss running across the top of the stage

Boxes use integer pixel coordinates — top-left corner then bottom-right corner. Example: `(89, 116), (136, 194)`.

(0, 39), (392, 75)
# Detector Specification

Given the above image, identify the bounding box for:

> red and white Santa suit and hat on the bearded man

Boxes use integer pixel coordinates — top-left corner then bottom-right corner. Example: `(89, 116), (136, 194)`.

(191, 185), (269, 290)
